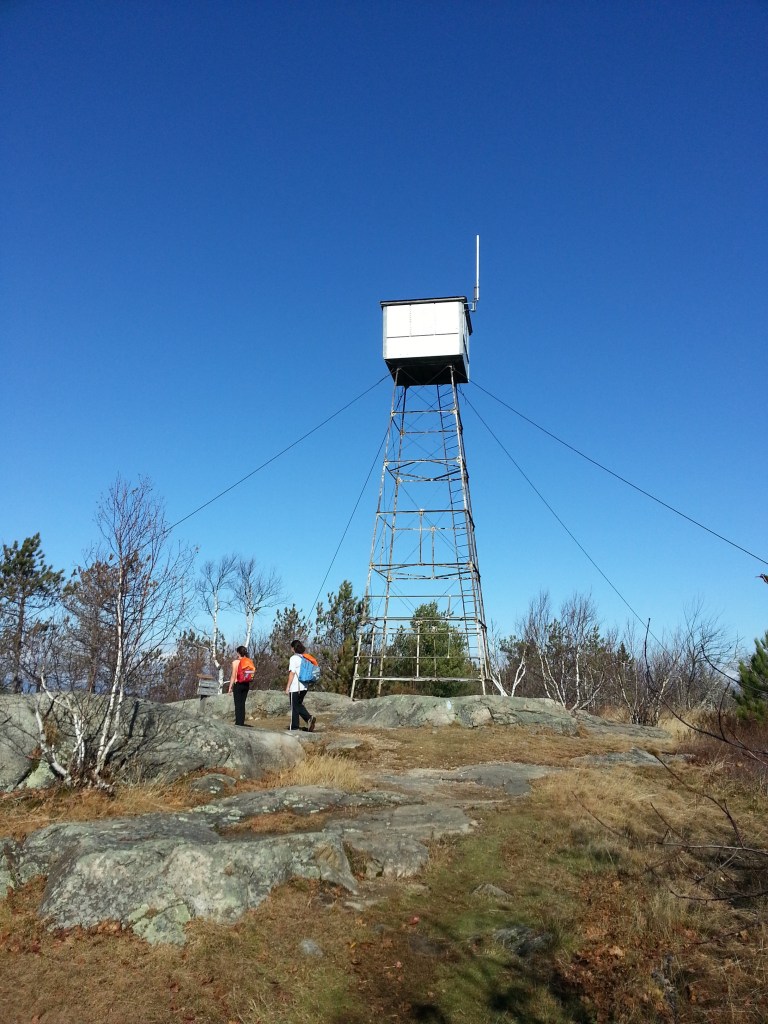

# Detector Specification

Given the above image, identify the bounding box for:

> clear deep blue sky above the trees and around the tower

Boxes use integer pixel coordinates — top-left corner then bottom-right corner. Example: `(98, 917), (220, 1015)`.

(0, 0), (768, 646)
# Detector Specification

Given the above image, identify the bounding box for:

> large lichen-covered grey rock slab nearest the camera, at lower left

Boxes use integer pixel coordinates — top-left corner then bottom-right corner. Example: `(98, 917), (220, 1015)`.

(0, 786), (472, 943)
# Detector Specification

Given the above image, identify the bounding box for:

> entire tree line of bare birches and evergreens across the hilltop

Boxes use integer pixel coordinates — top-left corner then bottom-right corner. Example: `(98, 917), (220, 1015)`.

(0, 478), (768, 725)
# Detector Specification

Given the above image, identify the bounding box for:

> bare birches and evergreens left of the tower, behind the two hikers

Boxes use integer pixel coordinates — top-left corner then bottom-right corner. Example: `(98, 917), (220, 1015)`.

(0, 478), (370, 700)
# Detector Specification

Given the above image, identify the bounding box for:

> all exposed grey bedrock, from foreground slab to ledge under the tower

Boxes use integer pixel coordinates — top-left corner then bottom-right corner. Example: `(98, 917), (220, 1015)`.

(0, 691), (666, 943)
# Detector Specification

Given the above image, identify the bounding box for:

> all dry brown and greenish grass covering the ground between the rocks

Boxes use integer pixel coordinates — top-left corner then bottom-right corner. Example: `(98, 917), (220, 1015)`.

(0, 728), (768, 1024)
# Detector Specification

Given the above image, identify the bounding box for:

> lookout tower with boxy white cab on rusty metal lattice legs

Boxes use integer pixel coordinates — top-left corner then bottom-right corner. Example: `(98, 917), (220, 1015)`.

(352, 296), (501, 696)
